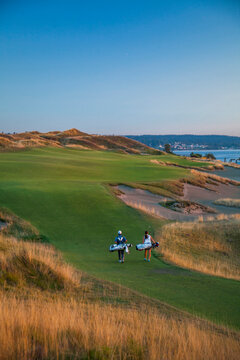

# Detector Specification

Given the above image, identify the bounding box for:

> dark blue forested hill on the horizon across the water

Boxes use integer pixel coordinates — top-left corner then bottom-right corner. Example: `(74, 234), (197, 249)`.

(126, 135), (240, 150)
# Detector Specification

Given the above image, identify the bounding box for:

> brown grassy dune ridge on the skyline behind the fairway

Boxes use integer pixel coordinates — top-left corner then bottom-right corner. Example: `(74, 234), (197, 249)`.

(0, 129), (161, 154)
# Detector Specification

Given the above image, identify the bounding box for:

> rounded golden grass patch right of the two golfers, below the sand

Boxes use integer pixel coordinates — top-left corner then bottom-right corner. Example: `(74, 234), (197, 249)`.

(158, 214), (240, 280)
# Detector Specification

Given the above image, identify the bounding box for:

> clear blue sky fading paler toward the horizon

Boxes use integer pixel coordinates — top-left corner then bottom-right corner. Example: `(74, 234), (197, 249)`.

(0, 0), (240, 136)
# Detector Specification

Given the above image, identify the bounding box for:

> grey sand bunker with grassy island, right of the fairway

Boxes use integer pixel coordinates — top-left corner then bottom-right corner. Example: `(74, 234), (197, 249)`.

(117, 177), (240, 221)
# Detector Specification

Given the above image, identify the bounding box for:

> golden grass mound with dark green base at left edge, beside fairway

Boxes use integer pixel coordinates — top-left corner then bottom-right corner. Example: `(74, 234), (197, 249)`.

(0, 234), (80, 290)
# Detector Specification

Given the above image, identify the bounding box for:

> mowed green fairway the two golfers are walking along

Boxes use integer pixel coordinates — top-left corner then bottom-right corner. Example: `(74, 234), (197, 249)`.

(0, 149), (240, 328)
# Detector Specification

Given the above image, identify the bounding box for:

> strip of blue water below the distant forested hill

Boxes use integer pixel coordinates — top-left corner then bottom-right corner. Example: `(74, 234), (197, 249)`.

(174, 149), (240, 163)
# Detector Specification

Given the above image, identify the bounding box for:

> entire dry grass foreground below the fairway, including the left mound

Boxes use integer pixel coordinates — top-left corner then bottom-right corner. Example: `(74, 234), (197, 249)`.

(0, 235), (240, 360)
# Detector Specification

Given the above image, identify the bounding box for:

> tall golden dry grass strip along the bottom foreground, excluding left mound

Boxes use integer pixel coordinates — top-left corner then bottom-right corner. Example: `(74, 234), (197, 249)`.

(0, 294), (240, 360)
